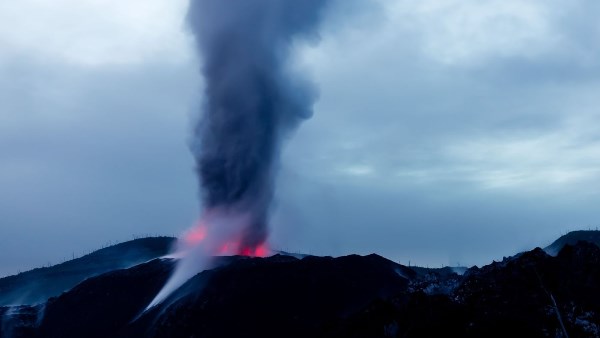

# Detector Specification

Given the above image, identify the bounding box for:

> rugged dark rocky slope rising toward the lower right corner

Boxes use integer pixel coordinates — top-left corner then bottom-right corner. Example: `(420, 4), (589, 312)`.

(328, 242), (600, 337)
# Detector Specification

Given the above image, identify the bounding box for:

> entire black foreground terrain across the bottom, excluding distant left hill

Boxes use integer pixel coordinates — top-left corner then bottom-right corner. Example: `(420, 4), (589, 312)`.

(0, 234), (600, 338)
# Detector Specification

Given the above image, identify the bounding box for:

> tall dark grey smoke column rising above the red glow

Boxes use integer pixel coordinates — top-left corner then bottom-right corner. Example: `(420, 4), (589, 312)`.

(188, 0), (326, 248)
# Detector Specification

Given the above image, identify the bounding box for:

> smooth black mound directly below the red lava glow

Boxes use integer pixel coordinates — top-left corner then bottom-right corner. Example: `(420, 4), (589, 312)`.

(134, 255), (414, 337)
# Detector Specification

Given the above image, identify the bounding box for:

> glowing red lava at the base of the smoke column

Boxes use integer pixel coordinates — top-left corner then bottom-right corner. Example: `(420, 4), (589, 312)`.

(183, 222), (271, 257)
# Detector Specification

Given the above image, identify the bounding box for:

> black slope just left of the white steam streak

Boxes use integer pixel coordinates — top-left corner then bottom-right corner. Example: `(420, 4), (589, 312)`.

(38, 259), (174, 338)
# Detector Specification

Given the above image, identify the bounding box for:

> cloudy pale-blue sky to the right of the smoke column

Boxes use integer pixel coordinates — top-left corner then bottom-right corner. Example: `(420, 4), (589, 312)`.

(278, 1), (600, 264)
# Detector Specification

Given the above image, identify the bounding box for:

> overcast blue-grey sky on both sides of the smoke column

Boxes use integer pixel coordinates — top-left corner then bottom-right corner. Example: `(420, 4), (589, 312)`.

(0, 0), (600, 276)
